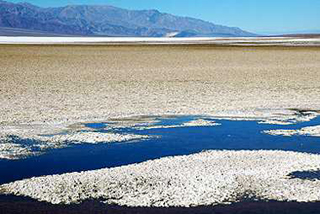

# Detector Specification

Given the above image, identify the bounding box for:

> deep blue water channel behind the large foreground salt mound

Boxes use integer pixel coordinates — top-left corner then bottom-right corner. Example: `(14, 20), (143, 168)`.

(0, 116), (320, 183)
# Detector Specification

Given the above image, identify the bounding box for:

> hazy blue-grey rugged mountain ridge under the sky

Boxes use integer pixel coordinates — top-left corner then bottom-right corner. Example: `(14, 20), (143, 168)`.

(0, 0), (255, 37)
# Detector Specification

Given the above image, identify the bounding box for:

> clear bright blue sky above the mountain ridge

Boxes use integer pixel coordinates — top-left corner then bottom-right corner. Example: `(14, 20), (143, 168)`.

(7, 0), (320, 33)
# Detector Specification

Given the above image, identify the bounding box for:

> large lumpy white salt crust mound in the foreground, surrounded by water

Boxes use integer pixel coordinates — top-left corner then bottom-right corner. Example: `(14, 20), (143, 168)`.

(0, 151), (320, 207)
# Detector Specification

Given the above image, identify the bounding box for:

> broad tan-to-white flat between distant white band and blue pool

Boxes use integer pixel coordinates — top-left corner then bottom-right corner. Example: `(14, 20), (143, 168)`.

(0, 45), (320, 126)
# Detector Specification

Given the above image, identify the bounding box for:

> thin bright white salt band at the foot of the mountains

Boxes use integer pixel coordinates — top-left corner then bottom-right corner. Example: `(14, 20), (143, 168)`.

(0, 34), (320, 45)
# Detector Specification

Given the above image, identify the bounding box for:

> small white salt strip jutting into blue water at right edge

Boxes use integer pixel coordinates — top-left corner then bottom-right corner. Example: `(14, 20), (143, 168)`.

(264, 126), (320, 137)
